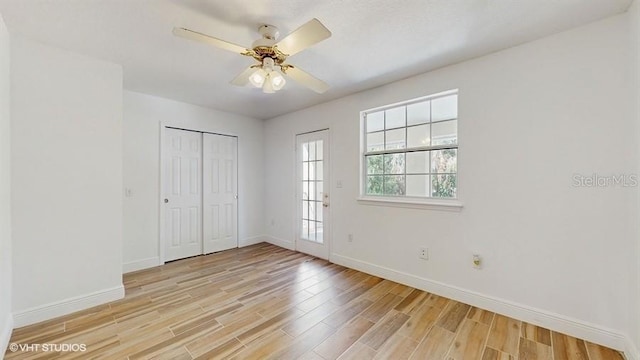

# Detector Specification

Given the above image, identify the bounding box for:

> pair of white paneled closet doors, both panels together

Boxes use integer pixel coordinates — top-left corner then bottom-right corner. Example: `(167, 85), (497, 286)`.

(162, 128), (238, 261)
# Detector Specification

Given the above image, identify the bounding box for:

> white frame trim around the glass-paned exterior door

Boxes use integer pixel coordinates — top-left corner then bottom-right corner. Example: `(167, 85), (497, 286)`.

(292, 127), (333, 261)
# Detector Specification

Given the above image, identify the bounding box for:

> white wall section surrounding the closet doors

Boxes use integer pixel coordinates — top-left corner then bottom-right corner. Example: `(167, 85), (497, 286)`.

(124, 91), (264, 272)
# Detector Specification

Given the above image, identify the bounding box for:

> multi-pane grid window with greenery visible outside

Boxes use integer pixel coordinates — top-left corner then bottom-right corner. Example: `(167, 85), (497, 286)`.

(362, 91), (458, 199)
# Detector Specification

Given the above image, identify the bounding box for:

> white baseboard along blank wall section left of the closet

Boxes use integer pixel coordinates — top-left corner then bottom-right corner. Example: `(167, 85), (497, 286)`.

(13, 285), (124, 328)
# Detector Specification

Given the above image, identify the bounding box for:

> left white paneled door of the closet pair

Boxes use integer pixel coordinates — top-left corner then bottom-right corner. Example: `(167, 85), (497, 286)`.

(162, 128), (202, 261)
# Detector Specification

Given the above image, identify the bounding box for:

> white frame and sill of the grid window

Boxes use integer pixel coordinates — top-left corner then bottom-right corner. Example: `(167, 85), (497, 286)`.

(357, 89), (462, 211)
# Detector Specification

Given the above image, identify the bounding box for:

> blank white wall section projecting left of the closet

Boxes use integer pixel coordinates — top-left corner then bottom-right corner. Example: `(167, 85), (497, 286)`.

(11, 37), (124, 326)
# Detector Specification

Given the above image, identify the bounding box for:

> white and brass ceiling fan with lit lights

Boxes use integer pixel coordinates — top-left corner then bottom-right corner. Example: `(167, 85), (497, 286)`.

(173, 19), (331, 94)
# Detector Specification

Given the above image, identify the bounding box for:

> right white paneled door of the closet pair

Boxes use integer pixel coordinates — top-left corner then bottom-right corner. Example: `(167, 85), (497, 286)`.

(202, 133), (238, 254)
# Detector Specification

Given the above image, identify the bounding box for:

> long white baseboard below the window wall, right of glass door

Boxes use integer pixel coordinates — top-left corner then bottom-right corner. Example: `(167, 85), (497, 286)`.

(331, 253), (640, 360)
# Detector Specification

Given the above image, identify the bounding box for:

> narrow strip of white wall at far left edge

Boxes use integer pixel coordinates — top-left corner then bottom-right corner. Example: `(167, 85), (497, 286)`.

(0, 12), (13, 353)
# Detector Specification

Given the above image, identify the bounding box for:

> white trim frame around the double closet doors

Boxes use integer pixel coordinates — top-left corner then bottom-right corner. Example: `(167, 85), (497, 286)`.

(157, 121), (240, 265)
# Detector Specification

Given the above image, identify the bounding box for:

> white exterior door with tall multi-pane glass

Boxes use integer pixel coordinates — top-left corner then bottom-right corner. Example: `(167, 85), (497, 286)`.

(296, 130), (330, 260)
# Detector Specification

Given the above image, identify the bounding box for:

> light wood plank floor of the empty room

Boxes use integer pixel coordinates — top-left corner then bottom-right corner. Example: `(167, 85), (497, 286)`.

(5, 244), (622, 360)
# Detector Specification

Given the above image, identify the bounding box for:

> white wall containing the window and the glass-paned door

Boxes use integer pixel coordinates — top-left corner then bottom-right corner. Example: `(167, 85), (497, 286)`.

(265, 10), (638, 348)
